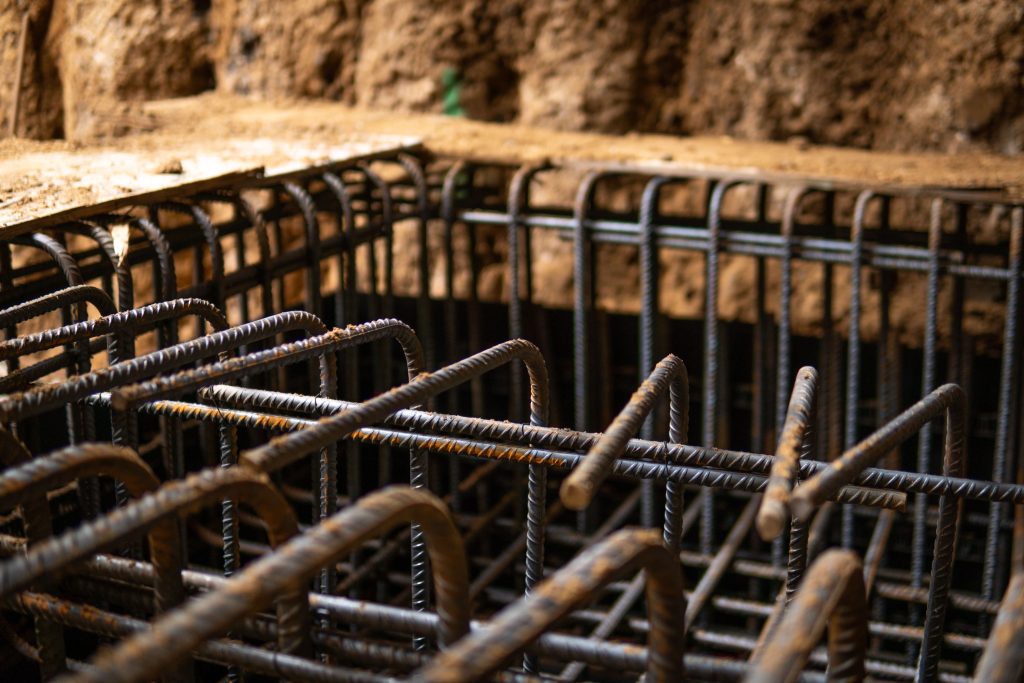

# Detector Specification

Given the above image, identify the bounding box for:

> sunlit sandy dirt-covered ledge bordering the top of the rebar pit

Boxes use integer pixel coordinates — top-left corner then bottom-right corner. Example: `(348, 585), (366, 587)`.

(9, 93), (1024, 233)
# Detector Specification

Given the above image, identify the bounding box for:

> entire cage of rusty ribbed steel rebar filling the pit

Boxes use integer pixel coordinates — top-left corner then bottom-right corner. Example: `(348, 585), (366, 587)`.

(0, 148), (1024, 682)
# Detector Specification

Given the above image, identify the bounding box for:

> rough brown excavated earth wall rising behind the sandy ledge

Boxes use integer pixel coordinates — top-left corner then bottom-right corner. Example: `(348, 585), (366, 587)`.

(0, 0), (1024, 154)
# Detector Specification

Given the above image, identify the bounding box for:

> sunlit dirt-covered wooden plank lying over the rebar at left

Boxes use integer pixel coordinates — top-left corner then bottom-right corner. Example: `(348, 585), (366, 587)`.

(0, 131), (418, 237)
